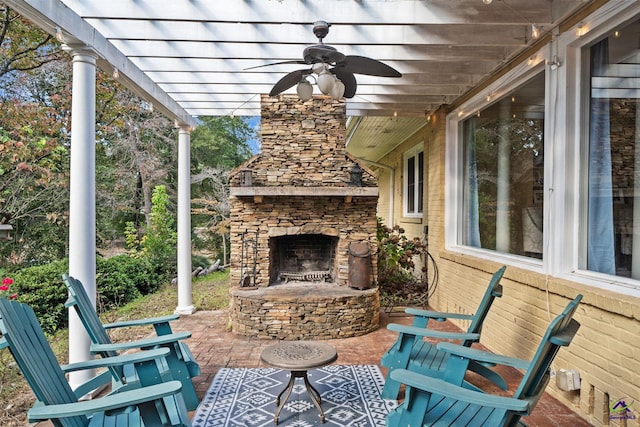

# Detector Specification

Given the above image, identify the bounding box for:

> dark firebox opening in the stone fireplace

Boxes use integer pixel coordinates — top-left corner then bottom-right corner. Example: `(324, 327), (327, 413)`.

(269, 234), (338, 285)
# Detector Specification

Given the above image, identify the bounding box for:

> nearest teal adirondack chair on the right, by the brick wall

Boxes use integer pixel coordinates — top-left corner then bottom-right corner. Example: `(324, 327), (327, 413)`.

(387, 295), (582, 427)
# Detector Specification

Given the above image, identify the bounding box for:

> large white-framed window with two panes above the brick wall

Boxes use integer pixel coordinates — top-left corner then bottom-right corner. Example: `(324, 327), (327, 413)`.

(444, 2), (640, 296)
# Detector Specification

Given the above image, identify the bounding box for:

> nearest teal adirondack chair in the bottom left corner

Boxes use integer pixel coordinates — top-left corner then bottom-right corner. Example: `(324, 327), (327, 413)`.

(0, 298), (191, 427)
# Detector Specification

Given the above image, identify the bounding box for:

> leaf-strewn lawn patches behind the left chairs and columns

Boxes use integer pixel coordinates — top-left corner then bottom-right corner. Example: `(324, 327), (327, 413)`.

(0, 272), (229, 427)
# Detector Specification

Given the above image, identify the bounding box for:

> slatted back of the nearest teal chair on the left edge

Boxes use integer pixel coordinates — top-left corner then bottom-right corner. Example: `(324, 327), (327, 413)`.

(0, 298), (89, 427)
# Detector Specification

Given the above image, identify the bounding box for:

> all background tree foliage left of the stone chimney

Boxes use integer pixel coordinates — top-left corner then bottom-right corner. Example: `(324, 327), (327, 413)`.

(0, 8), (255, 268)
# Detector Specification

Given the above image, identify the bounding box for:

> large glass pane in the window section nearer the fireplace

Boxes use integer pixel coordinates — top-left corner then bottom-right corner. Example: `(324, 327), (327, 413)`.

(459, 73), (545, 258)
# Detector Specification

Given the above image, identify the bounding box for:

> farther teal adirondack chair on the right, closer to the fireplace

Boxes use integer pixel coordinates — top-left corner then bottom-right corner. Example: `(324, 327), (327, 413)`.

(380, 266), (507, 399)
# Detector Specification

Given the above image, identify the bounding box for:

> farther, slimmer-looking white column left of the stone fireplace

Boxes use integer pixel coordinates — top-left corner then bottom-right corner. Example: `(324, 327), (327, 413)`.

(176, 126), (196, 314)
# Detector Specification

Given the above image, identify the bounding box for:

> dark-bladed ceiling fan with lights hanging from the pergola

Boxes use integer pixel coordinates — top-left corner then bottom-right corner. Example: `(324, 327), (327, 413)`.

(248, 21), (402, 101)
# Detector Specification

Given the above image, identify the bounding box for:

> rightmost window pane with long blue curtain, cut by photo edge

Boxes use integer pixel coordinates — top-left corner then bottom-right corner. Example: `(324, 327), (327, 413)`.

(581, 20), (640, 278)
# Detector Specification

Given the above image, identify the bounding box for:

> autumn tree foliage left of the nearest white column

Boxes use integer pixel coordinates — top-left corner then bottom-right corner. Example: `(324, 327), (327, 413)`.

(0, 10), (70, 264)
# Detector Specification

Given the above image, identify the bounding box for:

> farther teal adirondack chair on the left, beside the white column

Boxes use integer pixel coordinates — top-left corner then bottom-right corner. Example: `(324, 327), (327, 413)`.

(62, 274), (200, 411)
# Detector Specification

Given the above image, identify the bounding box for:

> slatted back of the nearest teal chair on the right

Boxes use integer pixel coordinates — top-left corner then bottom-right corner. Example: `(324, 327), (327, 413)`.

(513, 295), (582, 400)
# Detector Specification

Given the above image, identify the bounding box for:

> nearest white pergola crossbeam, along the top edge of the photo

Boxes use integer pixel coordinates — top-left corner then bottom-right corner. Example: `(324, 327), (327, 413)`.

(64, 0), (561, 25)
